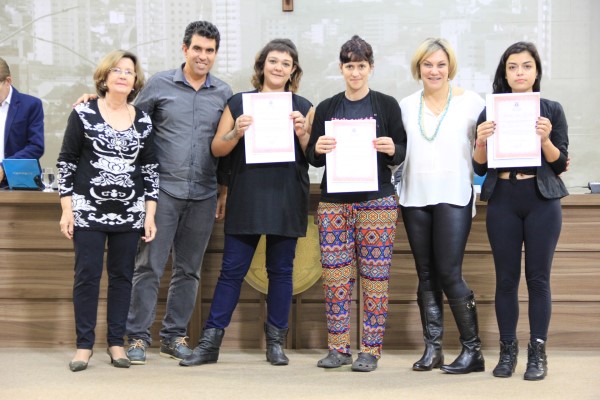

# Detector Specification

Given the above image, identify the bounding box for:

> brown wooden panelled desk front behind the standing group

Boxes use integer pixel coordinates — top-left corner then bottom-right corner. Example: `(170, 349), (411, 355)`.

(0, 187), (600, 350)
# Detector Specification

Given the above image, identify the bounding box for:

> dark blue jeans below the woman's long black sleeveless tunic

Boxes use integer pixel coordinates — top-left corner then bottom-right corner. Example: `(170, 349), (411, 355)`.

(205, 235), (298, 329)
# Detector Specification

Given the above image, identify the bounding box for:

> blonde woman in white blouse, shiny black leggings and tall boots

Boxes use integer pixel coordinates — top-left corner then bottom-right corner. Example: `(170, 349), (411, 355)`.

(400, 38), (485, 374)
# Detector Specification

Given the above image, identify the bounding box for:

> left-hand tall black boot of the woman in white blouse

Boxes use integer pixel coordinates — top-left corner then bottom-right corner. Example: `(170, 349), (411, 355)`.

(413, 292), (444, 371)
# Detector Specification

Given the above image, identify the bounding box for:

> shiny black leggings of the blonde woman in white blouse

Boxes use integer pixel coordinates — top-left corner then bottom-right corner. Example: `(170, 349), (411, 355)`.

(401, 194), (473, 299)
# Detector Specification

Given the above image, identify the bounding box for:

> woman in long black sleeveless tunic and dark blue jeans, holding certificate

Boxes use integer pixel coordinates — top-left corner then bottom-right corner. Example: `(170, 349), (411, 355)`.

(180, 39), (312, 366)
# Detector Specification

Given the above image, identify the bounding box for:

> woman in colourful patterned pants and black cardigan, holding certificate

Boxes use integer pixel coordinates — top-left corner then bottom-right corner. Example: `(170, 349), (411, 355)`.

(306, 36), (406, 372)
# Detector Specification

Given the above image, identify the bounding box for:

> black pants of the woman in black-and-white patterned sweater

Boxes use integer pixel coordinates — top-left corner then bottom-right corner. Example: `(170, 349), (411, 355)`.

(73, 230), (140, 349)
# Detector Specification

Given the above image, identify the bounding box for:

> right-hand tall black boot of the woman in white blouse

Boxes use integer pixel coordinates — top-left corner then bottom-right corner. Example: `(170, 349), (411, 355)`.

(441, 292), (485, 374)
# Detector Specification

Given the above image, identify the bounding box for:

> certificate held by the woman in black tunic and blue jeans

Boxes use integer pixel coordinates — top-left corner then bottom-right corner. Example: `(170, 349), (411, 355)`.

(242, 92), (296, 164)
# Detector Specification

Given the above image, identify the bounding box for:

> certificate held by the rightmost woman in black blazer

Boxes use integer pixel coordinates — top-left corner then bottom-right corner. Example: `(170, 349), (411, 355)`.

(486, 92), (541, 168)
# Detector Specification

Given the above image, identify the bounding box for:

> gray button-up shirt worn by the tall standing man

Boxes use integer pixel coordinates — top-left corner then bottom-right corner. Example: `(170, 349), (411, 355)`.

(135, 64), (233, 200)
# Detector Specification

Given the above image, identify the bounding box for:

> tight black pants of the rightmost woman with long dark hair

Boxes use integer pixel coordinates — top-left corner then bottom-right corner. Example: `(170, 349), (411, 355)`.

(487, 179), (562, 341)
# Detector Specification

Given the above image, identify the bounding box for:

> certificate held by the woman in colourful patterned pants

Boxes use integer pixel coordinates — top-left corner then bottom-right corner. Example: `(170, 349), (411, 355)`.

(325, 119), (379, 193)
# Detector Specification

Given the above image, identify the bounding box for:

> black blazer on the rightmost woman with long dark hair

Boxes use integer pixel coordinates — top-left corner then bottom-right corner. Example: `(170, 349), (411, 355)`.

(473, 99), (569, 201)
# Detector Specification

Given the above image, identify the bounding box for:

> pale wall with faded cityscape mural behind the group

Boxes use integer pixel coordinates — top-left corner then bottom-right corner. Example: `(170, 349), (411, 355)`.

(0, 0), (600, 192)
